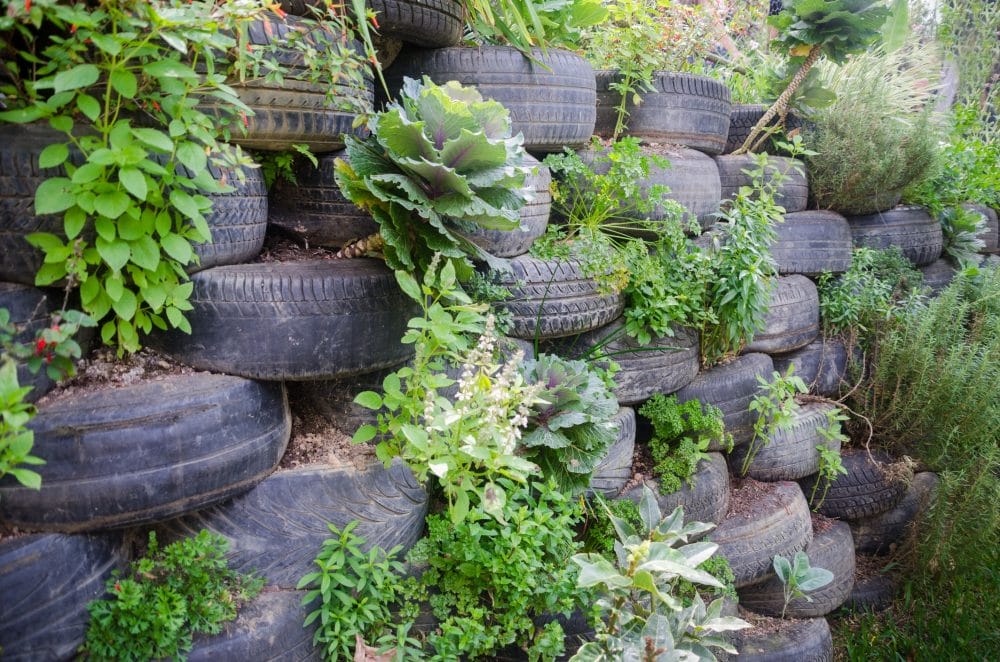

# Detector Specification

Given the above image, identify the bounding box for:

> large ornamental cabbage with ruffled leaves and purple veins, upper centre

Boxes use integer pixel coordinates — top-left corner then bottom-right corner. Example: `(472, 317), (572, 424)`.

(335, 76), (531, 272)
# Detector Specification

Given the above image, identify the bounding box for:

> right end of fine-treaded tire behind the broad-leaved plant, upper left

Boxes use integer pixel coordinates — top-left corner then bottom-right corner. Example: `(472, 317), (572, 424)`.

(188, 165), (268, 273)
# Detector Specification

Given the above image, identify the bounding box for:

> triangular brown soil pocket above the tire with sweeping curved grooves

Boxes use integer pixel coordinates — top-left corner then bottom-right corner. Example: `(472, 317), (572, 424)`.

(279, 400), (375, 469)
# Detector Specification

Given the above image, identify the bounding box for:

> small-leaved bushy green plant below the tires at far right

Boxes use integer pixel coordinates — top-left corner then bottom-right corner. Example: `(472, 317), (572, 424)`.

(817, 246), (924, 336)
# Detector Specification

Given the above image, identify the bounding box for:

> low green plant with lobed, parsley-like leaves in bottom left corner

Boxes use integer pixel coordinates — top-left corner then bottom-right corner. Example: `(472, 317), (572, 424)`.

(80, 531), (264, 661)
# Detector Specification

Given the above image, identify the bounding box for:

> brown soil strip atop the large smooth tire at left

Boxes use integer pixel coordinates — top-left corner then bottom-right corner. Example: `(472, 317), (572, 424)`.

(38, 347), (198, 407)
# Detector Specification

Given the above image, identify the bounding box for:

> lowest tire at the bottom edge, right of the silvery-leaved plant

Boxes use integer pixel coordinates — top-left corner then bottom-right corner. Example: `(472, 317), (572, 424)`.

(734, 618), (833, 662)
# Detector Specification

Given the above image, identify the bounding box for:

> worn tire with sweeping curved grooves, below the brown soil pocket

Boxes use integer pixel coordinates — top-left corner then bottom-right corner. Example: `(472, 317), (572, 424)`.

(157, 460), (427, 589)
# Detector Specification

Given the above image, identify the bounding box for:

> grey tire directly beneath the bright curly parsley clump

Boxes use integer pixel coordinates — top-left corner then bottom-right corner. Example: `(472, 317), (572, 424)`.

(624, 453), (730, 524)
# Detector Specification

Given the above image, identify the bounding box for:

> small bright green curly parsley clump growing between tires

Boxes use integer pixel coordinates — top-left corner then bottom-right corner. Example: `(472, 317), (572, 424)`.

(639, 393), (733, 494)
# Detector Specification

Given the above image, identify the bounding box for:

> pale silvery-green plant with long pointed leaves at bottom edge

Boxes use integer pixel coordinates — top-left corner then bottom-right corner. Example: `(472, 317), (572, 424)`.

(573, 486), (749, 662)
